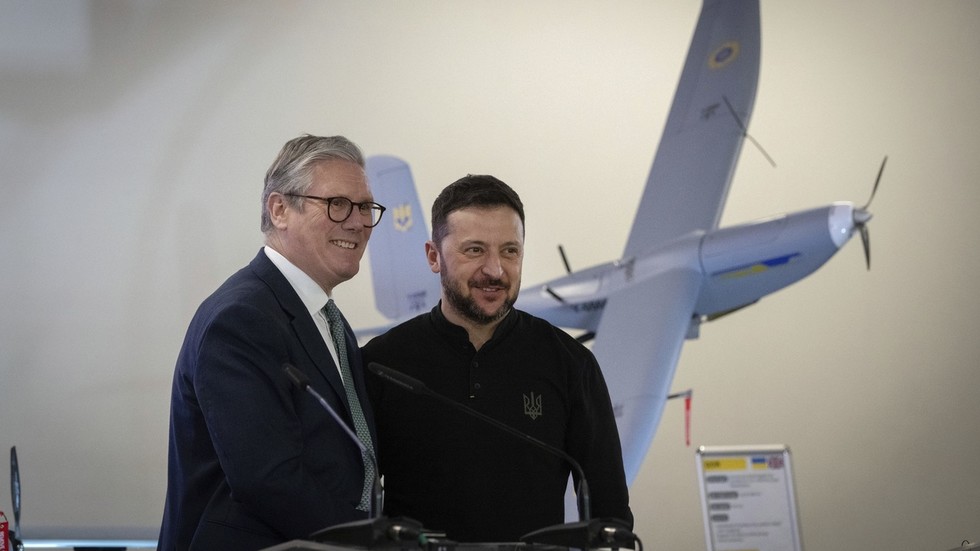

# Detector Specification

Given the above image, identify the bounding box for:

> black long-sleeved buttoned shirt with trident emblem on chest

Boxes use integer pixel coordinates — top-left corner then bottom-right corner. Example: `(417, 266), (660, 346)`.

(363, 305), (632, 542)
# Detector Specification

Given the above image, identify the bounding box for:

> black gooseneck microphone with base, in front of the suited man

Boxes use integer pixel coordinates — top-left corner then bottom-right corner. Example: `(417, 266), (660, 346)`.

(282, 363), (422, 548)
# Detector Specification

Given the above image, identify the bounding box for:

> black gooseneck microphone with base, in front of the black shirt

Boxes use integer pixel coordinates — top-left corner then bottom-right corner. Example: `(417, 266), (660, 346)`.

(368, 362), (638, 549)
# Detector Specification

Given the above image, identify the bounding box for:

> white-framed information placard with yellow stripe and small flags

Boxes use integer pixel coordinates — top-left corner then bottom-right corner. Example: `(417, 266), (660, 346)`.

(697, 445), (803, 551)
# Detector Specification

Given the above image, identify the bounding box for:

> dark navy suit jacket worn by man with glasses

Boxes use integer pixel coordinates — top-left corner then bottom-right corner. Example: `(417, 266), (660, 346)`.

(159, 251), (376, 551)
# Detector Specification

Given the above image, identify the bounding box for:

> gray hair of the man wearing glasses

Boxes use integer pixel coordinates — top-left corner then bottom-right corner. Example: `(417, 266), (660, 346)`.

(262, 134), (364, 233)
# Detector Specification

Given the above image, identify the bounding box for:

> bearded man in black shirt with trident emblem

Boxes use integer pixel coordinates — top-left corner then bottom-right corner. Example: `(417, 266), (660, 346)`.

(363, 175), (632, 542)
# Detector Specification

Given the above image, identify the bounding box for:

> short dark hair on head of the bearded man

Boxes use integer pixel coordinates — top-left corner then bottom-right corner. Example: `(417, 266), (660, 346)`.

(432, 174), (524, 247)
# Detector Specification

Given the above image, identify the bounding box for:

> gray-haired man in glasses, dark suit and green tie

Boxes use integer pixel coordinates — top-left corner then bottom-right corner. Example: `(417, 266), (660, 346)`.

(159, 135), (384, 551)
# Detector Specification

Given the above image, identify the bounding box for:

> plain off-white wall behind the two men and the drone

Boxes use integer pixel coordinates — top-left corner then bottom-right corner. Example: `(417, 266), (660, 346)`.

(0, 0), (980, 549)
